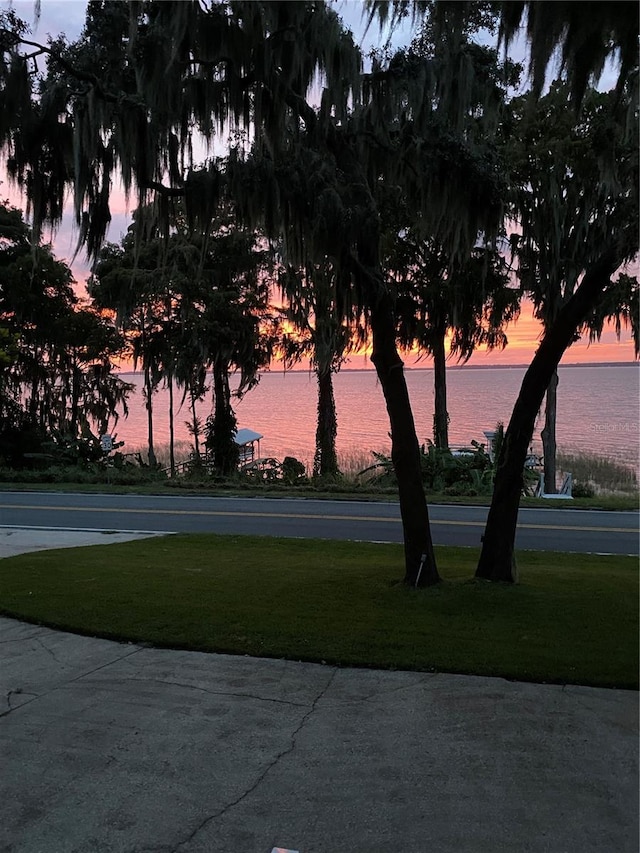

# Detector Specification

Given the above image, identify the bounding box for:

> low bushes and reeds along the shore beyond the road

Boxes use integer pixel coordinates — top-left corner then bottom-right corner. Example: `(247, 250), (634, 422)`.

(0, 425), (639, 500)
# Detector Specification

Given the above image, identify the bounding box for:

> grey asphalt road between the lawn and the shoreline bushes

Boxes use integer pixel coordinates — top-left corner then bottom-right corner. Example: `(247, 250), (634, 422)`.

(0, 492), (640, 555)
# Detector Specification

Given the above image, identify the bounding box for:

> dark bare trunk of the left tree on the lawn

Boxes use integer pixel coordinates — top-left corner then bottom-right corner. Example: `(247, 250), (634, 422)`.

(371, 286), (440, 587)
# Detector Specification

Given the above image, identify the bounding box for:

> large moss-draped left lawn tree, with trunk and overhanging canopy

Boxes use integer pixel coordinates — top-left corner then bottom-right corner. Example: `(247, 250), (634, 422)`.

(0, 0), (510, 584)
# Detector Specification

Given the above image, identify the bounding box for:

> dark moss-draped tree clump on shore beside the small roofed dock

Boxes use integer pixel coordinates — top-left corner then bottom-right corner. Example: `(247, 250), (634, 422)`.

(90, 201), (272, 474)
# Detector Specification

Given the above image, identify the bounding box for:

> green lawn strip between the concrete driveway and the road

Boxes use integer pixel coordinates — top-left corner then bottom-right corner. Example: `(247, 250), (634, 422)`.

(0, 535), (638, 688)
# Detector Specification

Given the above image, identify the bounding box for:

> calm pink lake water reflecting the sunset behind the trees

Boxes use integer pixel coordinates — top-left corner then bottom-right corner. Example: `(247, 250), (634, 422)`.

(114, 364), (640, 470)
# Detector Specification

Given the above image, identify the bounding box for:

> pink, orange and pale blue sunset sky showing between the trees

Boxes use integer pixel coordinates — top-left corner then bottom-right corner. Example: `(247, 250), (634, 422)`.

(0, 0), (638, 368)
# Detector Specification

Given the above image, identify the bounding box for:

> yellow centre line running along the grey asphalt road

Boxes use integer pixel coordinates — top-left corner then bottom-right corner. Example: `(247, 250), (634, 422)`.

(0, 504), (640, 533)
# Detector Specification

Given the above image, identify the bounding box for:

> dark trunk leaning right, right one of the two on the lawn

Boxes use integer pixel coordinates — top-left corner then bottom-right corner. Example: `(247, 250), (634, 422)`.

(476, 250), (619, 583)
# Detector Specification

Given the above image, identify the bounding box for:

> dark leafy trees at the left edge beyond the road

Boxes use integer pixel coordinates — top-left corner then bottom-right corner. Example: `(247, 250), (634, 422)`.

(0, 203), (130, 466)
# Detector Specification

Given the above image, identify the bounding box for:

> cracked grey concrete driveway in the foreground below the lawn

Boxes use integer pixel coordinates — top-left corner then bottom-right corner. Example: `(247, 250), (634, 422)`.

(0, 528), (638, 853)
